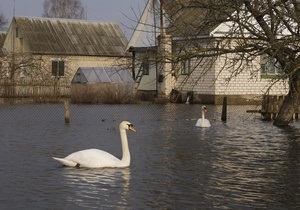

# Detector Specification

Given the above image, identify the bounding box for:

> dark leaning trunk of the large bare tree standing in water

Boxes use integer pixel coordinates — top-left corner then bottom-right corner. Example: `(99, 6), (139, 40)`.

(273, 73), (300, 126)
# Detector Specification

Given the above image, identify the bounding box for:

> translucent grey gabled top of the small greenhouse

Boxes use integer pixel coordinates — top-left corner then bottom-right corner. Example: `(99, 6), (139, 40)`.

(72, 66), (134, 83)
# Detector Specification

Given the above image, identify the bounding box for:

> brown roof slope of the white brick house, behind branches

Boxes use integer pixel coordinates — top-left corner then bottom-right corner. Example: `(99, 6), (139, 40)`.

(164, 0), (241, 38)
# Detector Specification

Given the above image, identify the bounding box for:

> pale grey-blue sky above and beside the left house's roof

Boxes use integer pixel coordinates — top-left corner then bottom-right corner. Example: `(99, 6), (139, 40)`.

(0, 0), (146, 39)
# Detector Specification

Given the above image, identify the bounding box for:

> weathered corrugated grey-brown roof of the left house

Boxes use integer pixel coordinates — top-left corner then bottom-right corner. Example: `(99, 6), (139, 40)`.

(14, 17), (128, 56)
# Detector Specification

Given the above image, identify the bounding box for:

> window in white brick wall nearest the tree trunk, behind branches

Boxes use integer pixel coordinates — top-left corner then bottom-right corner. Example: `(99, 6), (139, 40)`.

(260, 55), (282, 76)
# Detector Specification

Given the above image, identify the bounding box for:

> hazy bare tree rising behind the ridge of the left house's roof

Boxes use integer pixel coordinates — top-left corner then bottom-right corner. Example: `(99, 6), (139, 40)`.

(43, 0), (85, 19)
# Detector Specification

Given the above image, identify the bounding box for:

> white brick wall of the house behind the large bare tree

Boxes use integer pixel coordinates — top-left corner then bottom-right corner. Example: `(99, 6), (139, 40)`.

(176, 52), (288, 95)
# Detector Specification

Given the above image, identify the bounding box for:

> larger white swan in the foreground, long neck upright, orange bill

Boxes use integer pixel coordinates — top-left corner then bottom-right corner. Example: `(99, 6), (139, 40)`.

(53, 121), (136, 168)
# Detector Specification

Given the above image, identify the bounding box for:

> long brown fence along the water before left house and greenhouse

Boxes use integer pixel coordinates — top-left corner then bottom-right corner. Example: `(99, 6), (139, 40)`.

(0, 80), (135, 104)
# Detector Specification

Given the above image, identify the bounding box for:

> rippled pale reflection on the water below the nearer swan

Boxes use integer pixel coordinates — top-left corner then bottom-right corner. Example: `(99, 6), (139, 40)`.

(62, 167), (130, 208)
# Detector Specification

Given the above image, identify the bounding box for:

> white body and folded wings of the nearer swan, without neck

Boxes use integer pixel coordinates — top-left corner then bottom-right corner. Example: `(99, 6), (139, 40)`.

(55, 149), (120, 168)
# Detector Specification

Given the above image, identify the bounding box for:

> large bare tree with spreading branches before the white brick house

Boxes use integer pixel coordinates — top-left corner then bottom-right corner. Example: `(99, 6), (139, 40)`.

(164, 0), (300, 125)
